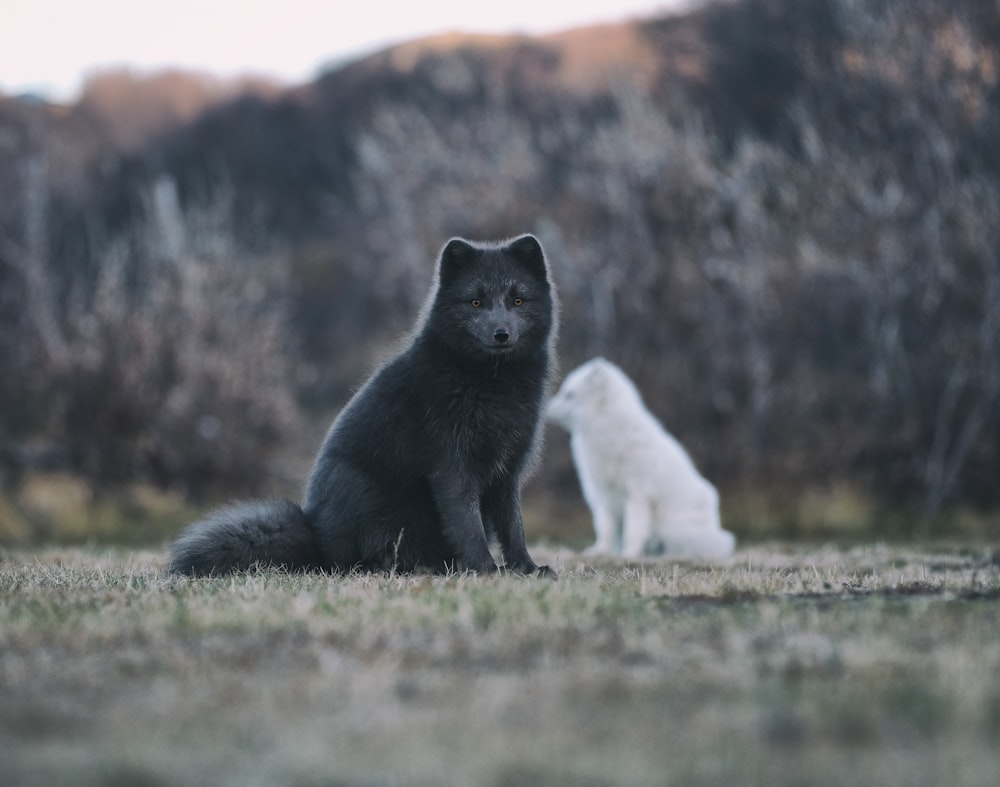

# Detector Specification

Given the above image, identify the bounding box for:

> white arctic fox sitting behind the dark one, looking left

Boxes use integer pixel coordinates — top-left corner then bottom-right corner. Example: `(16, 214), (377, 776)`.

(547, 358), (736, 557)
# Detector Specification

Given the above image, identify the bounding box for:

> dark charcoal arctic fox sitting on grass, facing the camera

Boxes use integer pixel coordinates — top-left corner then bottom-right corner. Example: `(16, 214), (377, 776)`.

(170, 235), (557, 575)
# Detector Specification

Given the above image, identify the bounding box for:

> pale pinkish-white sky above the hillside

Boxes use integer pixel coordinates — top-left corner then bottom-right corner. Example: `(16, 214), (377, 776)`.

(0, 0), (682, 101)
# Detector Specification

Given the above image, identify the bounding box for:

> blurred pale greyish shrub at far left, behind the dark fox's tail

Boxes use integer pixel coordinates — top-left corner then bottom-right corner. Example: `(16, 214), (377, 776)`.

(6, 179), (297, 497)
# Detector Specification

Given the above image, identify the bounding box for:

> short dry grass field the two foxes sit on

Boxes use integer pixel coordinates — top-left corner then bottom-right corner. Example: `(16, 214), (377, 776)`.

(0, 543), (1000, 787)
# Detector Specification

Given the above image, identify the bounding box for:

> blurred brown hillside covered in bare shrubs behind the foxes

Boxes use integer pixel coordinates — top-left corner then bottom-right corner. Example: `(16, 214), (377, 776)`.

(0, 0), (1000, 530)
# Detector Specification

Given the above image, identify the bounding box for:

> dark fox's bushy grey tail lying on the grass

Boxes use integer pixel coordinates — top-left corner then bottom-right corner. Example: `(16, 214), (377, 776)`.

(169, 500), (319, 576)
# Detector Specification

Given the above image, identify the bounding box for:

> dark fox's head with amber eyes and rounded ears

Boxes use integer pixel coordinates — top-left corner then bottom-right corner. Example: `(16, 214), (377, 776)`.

(428, 235), (553, 358)
